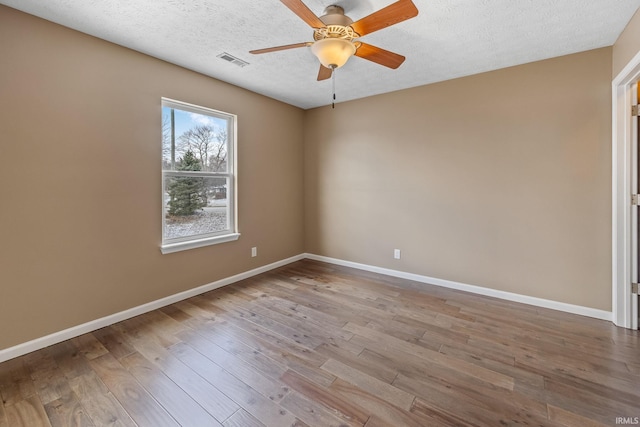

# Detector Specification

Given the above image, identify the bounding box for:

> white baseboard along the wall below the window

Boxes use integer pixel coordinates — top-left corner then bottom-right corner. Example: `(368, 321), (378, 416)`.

(0, 254), (304, 363)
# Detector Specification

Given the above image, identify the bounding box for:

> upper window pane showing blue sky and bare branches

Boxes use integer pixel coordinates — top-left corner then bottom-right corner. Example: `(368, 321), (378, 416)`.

(162, 106), (229, 172)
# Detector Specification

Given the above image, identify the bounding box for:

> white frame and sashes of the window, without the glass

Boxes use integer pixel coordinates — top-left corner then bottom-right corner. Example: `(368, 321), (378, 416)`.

(160, 98), (240, 254)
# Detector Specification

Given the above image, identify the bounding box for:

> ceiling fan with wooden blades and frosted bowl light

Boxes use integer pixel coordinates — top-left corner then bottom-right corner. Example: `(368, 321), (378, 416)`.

(250, 0), (418, 80)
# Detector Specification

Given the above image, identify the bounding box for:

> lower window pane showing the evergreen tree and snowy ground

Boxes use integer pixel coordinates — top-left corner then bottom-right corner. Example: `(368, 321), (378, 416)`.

(164, 176), (230, 240)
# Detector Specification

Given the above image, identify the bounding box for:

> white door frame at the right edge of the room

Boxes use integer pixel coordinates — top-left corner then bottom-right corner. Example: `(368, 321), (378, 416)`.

(611, 52), (640, 328)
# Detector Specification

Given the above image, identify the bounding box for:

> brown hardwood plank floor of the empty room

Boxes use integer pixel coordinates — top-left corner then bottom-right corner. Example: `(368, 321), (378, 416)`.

(0, 260), (640, 427)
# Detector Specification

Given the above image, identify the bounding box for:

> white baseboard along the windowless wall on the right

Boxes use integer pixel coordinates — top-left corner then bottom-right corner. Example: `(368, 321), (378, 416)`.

(304, 254), (613, 321)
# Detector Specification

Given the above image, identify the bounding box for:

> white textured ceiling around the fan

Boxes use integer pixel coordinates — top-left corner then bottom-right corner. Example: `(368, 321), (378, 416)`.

(0, 0), (640, 108)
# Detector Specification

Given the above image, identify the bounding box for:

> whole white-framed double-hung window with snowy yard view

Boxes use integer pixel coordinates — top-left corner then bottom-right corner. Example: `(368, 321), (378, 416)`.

(161, 99), (240, 253)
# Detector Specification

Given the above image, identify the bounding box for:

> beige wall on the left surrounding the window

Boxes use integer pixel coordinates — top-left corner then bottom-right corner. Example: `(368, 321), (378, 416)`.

(0, 6), (304, 349)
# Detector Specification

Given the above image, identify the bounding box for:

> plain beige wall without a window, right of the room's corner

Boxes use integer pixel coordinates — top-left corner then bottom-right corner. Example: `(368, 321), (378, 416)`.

(305, 48), (611, 310)
